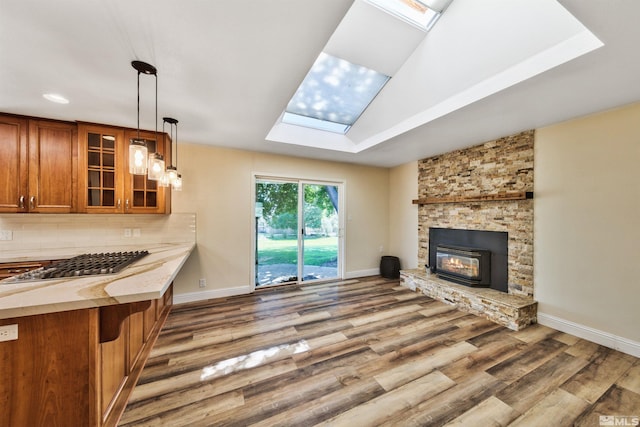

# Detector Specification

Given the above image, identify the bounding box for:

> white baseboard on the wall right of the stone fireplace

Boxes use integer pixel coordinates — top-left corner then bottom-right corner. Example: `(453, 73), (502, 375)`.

(538, 312), (640, 357)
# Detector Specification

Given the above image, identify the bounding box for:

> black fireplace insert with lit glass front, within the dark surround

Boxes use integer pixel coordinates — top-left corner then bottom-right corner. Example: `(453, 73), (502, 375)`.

(436, 245), (491, 287)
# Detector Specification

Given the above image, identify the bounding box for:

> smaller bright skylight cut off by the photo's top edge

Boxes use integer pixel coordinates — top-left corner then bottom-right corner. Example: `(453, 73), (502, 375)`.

(366, 0), (451, 31)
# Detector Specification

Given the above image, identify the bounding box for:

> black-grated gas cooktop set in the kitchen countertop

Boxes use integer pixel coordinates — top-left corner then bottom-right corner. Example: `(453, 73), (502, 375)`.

(3, 251), (149, 283)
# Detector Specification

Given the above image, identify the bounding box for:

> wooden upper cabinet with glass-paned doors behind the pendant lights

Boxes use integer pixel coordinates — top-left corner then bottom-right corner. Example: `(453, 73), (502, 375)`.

(78, 123), (171, 214)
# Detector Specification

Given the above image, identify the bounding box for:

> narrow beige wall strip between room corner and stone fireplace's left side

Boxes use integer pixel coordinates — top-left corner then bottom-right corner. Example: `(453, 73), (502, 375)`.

(388, 162), (418, 269)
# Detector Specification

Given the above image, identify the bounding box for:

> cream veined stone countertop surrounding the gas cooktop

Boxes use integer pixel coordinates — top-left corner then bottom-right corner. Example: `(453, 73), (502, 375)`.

(0, 243), (195, 319)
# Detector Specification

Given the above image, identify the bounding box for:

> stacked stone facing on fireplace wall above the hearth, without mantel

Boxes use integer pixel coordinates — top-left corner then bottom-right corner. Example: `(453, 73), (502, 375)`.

(418, 130), (534, 297)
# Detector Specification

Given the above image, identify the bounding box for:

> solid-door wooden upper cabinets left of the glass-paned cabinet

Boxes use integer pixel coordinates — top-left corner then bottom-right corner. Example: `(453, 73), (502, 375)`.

(0, 116), (78, 213)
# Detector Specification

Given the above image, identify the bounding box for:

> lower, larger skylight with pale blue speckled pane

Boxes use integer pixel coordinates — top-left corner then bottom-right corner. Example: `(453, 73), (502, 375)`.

(282, 52), (389, 134)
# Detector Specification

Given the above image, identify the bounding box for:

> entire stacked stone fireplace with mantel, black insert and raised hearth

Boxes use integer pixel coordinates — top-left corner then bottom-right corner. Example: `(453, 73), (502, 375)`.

(401, 131), (536, 330)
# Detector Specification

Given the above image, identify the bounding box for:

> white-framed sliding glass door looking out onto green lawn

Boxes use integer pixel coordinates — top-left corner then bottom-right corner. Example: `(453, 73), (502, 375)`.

(255, 177), (342, 287)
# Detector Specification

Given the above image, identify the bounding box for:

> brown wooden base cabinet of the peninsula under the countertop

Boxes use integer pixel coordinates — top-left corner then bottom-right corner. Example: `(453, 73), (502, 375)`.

(0, 288), (171, 427)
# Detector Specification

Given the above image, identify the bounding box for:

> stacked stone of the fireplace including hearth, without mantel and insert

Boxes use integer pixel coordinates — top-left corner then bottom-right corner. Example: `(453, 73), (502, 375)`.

(400, 131), (537, 330)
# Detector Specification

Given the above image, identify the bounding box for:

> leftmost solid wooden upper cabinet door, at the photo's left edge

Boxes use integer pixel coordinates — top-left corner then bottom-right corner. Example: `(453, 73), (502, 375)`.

(0, 115), (29, 212)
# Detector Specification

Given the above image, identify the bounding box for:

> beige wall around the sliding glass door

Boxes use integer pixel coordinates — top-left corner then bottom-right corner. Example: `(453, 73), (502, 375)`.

(172, 143), (389, 301)
